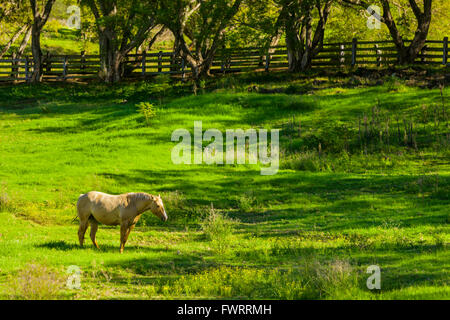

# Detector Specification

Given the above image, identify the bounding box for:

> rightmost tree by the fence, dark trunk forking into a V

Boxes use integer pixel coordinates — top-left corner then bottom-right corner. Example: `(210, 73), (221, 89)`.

(342, 0), (432, 64)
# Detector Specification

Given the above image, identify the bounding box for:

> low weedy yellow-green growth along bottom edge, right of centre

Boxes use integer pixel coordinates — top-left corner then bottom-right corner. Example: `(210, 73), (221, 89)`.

(167, 258), (358, 300)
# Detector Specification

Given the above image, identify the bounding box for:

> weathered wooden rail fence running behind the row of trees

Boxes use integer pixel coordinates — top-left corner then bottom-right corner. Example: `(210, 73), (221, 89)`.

(0, 37), (449, 81)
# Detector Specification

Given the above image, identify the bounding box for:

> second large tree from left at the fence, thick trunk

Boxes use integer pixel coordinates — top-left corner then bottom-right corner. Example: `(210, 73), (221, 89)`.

(83, 0), (157, 83)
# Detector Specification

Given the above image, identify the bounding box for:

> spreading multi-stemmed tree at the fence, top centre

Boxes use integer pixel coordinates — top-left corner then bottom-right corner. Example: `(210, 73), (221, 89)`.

(159, 0), (242, 79)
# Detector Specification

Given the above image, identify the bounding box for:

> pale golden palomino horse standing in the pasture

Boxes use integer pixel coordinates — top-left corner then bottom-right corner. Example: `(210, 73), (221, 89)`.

(77, 191), (167, 253)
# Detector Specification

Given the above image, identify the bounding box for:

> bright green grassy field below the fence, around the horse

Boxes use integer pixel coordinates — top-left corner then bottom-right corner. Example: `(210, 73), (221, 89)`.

(0, 74), (450, 299)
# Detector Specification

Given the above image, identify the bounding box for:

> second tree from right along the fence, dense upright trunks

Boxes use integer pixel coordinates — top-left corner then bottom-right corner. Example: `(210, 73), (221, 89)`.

(277, 0), (332, 71)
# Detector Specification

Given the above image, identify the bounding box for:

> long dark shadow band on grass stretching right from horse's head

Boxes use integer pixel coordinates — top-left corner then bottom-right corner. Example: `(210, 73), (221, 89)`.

(99, 166), (450, 234)
